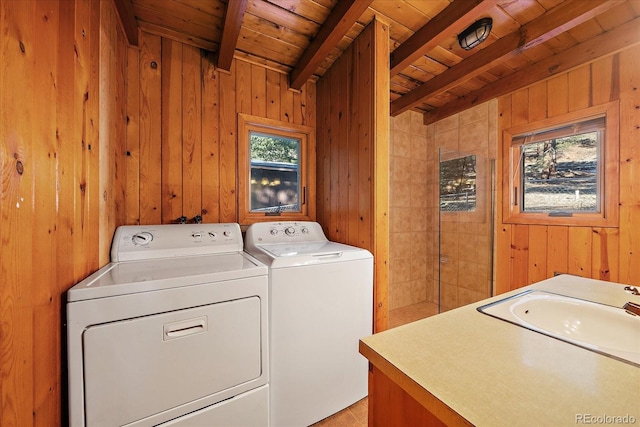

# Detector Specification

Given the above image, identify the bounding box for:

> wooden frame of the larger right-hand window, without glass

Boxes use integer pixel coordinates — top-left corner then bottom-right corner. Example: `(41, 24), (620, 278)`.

(502, 101), (620, 227)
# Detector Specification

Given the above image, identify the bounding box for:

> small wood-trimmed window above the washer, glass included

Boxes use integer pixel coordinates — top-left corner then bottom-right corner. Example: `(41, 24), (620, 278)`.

(238, 114), (315, 225)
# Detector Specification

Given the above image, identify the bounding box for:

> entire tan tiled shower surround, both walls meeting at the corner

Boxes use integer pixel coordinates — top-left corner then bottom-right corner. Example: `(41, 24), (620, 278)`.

(389, 100), (498, 311)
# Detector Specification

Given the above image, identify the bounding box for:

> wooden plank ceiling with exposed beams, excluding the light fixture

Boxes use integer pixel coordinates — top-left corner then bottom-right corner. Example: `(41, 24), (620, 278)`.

(115, 0), (640, 123)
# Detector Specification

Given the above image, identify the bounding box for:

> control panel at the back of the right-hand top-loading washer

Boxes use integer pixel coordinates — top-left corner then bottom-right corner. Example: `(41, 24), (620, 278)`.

(245, 221), (327, 245)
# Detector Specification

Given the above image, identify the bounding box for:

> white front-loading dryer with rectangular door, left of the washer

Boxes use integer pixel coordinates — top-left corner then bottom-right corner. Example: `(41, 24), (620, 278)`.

(67, 224), (269, 427)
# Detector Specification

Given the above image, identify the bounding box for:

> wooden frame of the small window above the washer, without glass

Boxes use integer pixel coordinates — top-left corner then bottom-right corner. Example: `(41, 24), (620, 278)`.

(237, 113), (316, 225)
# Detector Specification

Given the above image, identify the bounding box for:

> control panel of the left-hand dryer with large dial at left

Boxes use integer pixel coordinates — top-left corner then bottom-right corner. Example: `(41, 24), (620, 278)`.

(111, 223), (243, 262)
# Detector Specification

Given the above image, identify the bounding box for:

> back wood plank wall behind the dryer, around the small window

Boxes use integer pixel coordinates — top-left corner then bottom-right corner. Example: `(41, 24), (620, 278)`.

(125, 32), (316, 224)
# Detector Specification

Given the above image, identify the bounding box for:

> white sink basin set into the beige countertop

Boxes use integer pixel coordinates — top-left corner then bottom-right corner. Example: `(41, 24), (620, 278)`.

(478, 290), (640, 366)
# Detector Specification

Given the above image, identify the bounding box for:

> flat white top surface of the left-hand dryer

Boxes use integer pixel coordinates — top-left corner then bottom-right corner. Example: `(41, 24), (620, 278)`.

(67, 252), (268, 302)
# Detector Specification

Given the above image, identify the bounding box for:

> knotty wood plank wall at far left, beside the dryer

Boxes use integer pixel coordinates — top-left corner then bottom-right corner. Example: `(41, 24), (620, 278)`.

(0, 0), (126, 427)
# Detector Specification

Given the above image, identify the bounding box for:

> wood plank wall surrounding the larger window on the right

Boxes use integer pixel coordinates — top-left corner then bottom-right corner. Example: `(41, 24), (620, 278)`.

(496, 47), (640, 293)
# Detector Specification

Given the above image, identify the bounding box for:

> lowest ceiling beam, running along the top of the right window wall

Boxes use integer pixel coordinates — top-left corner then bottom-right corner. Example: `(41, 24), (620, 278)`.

(424, 18), (640, 125)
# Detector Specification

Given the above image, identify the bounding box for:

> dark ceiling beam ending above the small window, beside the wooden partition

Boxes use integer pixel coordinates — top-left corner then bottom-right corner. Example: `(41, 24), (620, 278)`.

(290, 0), (372, 90)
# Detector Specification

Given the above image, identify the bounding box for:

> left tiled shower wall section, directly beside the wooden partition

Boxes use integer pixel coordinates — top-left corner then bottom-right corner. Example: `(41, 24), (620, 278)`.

(389, 111), (438, 310)
